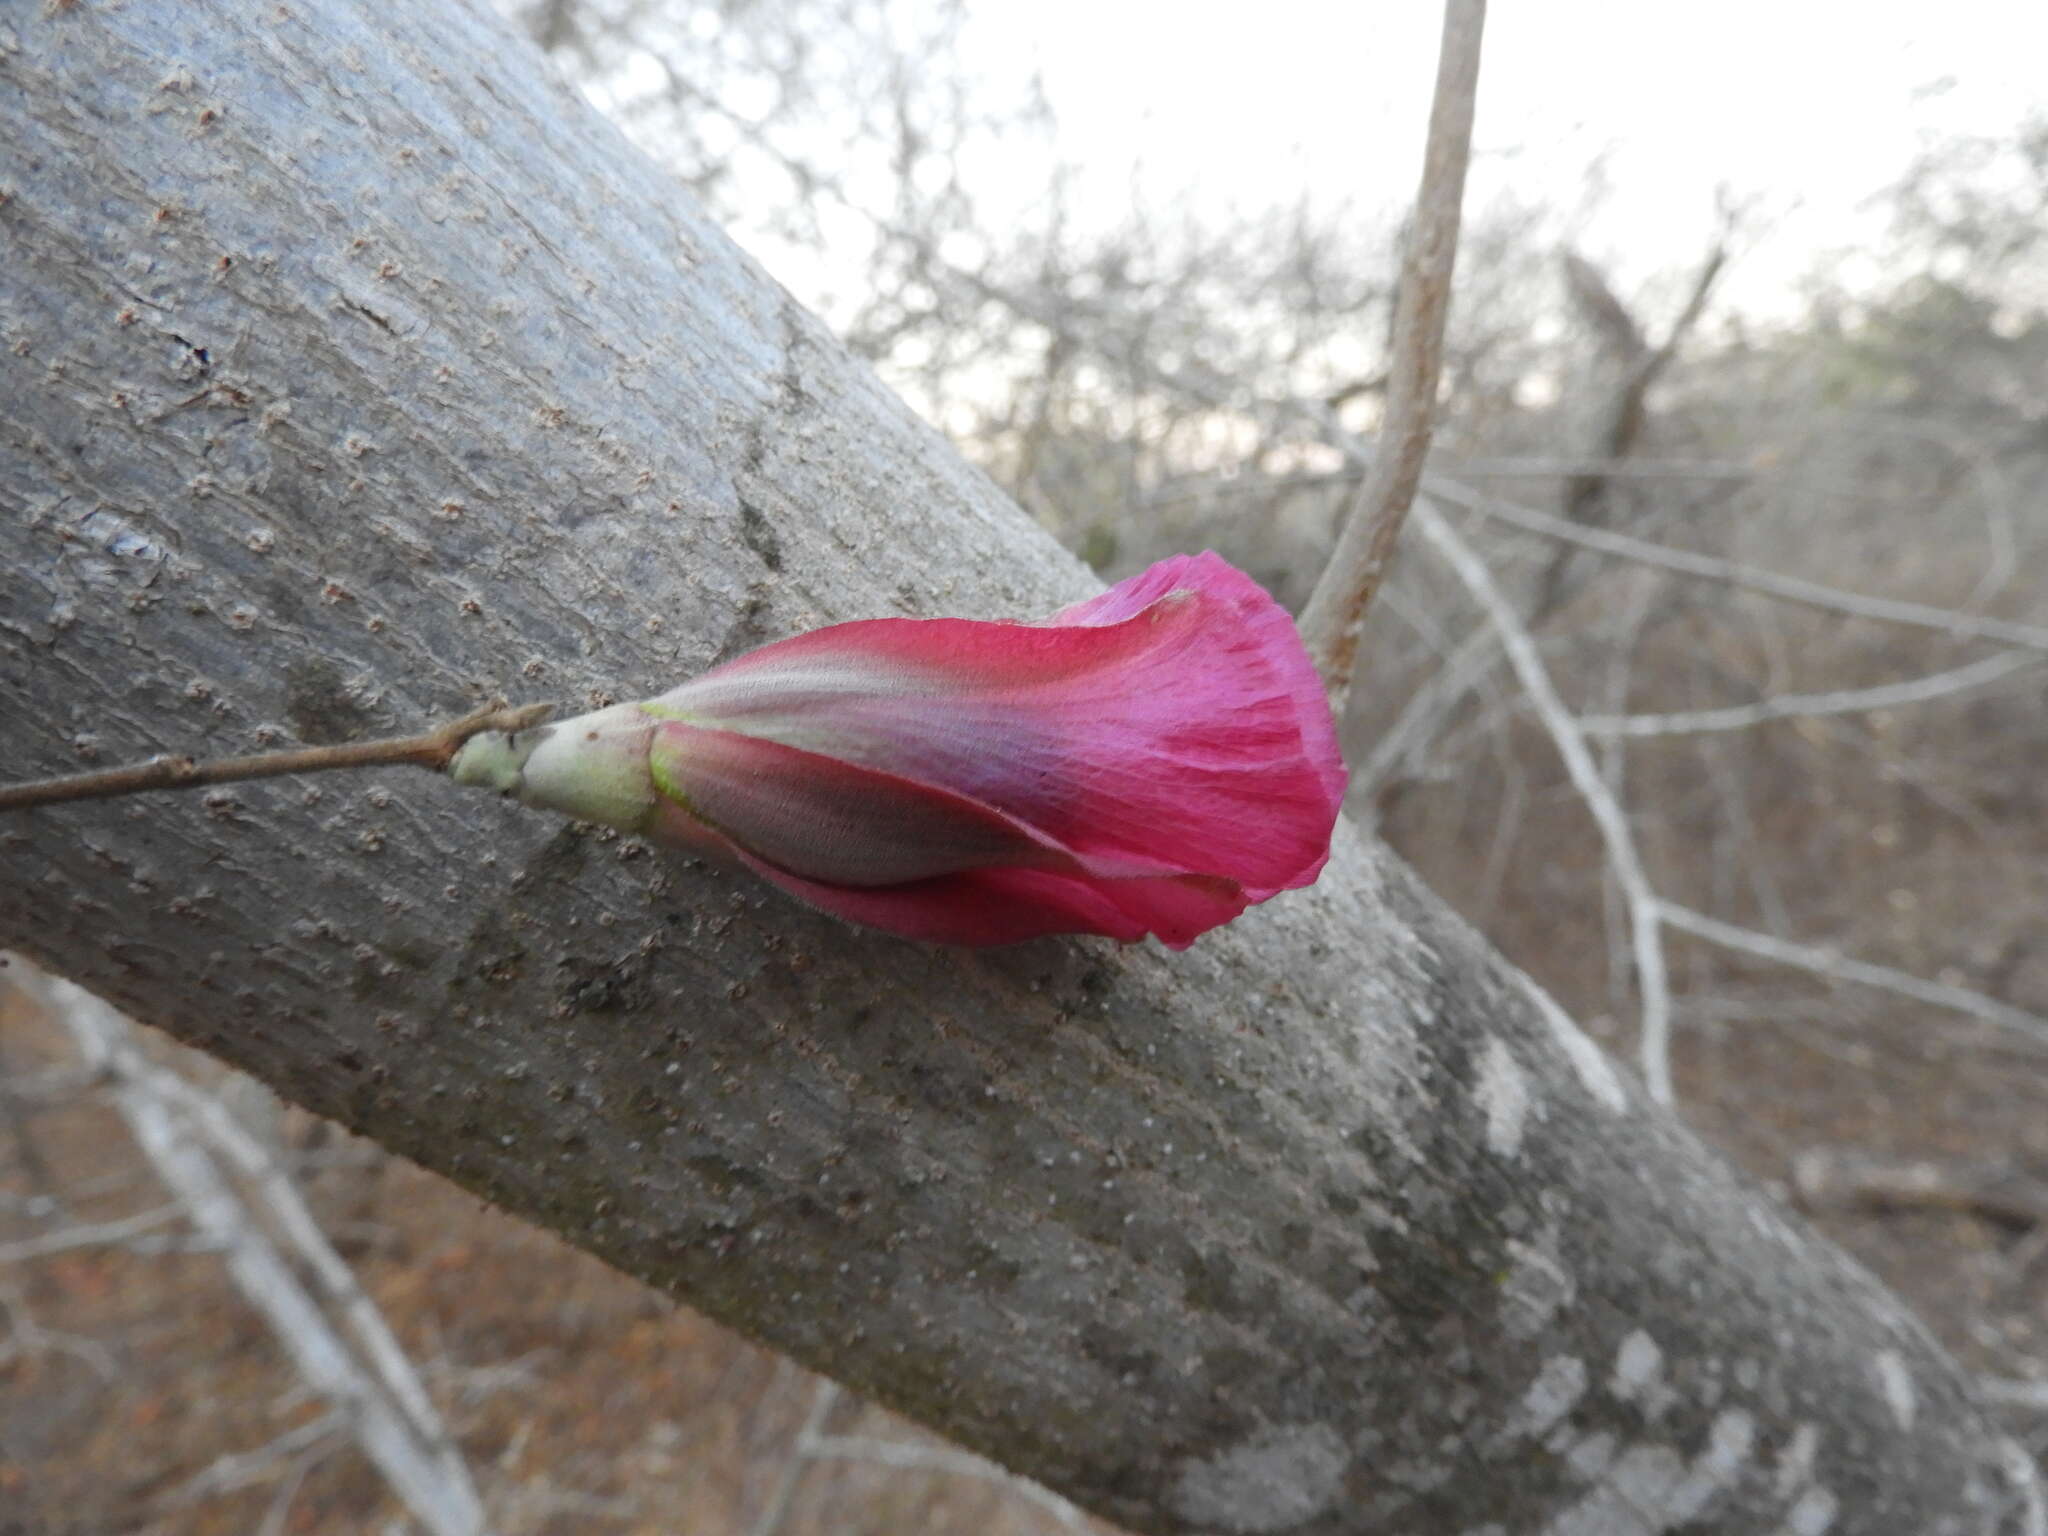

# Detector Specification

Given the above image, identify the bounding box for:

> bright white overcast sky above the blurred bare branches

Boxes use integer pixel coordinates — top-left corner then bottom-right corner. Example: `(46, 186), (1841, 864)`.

(965, 0), (2048, 309)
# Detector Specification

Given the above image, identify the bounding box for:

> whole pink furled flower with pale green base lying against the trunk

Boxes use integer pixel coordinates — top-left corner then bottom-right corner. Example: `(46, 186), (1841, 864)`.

(451, 555), (1343, 948)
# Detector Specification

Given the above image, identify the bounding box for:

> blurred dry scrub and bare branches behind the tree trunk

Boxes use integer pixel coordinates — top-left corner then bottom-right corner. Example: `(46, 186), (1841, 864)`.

(12, 0), (2048, 1536)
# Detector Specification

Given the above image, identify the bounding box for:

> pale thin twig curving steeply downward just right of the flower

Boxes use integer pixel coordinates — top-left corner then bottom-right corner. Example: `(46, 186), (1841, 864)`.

(1415, 500), (1673, 1104)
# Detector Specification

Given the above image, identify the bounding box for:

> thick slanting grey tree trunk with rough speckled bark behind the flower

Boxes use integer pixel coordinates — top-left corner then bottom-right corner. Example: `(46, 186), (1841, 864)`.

(0, 0), (2040, 1536)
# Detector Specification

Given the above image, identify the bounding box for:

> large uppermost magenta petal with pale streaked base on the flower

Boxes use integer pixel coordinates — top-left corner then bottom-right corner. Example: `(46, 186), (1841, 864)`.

(649, 555), (1343, 901)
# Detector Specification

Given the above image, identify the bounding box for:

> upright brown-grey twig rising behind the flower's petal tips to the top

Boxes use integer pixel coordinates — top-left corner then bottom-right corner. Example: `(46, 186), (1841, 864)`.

(1300, 0), (1487, 696)
